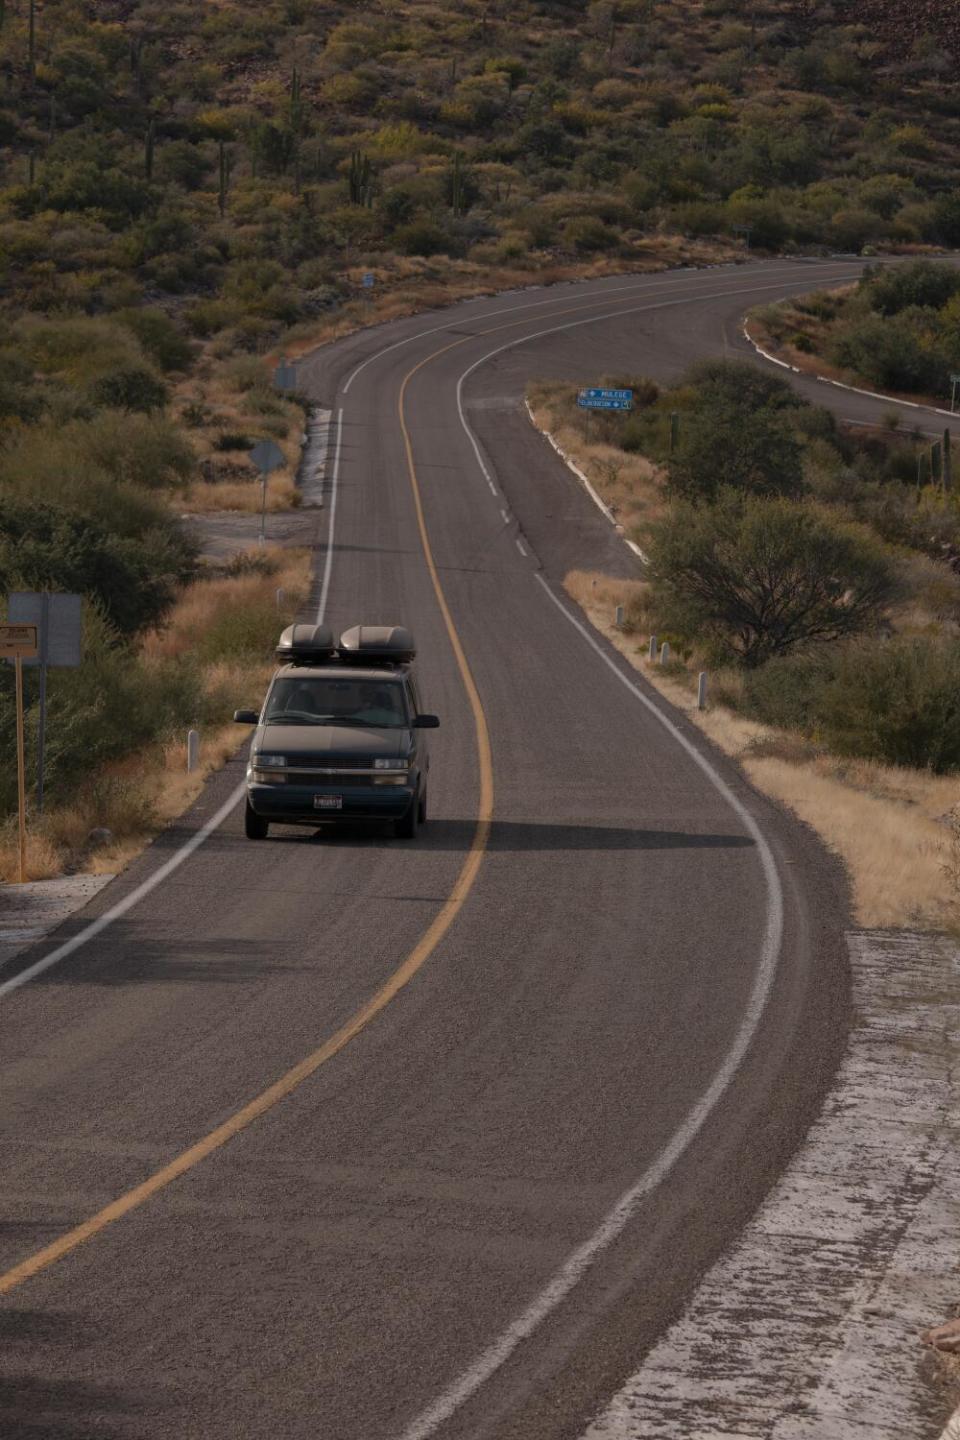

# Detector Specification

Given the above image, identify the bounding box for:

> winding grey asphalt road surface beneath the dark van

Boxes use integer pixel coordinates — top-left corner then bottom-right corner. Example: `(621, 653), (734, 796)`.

(0, 261), (932, 1440)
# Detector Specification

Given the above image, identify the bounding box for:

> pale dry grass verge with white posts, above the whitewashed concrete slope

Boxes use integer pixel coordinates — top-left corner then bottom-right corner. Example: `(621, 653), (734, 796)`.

(566, 572), (960, 929)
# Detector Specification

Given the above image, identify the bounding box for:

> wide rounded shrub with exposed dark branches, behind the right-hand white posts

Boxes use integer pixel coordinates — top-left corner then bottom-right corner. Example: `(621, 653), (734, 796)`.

(646, 491), (895, 668)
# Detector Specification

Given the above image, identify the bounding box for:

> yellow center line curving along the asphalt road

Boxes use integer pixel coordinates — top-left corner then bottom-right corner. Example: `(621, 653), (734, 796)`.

(0, 280), (693, 1295)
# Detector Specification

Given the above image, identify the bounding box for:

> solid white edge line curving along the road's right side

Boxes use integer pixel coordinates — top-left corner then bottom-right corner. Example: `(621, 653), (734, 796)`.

(402, 575), (783, 1440)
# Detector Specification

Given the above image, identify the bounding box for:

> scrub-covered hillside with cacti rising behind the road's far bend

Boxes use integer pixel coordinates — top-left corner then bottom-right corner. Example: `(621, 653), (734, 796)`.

(0, 0), (960, 348)
